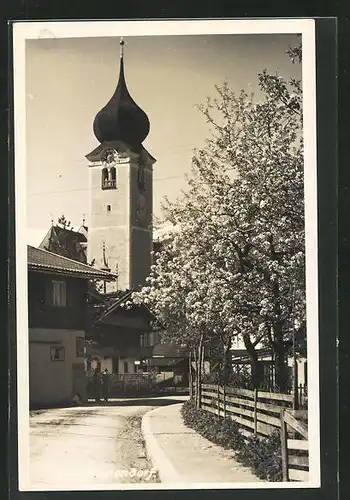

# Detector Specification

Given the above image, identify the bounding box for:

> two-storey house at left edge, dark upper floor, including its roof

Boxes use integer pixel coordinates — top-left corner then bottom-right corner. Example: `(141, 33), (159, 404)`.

(28, 246), (115, 408)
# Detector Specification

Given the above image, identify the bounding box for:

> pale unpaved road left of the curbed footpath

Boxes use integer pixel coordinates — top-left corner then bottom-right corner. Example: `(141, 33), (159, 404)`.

(30, 397), (183, 490)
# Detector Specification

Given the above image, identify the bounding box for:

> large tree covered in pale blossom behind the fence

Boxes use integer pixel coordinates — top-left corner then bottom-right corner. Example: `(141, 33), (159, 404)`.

(138, 43), (306, 392)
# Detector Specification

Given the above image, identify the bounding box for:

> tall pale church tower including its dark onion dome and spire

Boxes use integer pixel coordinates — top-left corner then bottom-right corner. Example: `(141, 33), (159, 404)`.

(86, 41), (156, 291)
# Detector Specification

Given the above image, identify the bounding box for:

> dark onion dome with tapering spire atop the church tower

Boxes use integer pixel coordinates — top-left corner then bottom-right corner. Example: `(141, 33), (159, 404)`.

(93, 40), (150, 146)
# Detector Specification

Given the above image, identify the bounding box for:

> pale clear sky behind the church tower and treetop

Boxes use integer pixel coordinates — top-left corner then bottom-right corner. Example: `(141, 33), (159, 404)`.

(25, 34), (301, 245)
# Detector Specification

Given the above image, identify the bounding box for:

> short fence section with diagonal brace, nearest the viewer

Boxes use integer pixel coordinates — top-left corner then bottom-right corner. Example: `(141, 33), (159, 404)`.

(281, 410), (309, 481)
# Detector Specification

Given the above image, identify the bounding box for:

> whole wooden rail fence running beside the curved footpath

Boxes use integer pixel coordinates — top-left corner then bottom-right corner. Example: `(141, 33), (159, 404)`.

(200, 384), (309, 481)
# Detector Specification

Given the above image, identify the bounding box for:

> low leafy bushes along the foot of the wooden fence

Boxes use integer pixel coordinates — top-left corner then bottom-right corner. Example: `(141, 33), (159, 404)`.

(181, 400), (282, 481)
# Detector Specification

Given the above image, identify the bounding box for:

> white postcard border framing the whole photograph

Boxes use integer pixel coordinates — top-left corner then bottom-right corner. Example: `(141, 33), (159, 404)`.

(13, 19), (321, 491)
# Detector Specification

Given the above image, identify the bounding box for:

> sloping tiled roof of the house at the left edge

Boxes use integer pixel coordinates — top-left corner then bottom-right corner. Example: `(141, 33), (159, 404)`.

(27, 245), (117, 281)
